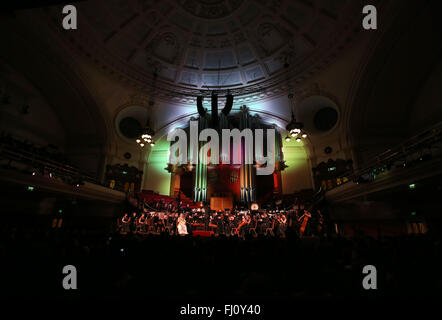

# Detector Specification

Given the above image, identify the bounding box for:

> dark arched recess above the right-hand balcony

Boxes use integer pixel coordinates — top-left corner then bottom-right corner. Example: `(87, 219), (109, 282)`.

(347, 2), (442, 168)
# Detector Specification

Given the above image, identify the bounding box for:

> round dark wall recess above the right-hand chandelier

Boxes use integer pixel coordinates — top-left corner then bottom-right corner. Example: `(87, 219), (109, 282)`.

(295, 95), (340, 136)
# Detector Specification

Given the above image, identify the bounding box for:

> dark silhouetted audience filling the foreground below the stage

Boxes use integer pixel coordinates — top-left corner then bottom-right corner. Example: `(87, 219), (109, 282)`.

(0, 216), (442, 298)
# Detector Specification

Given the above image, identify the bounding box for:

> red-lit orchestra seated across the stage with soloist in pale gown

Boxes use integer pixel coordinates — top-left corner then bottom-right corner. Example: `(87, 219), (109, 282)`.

(119, 203), (324, 238)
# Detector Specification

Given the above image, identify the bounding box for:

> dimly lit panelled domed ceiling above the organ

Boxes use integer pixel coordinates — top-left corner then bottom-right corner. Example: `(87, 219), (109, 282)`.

(40, 0), (361, 100)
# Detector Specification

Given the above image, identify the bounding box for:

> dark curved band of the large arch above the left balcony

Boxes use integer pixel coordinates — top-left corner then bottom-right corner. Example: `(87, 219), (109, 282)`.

(0, 21), (108, 178)
